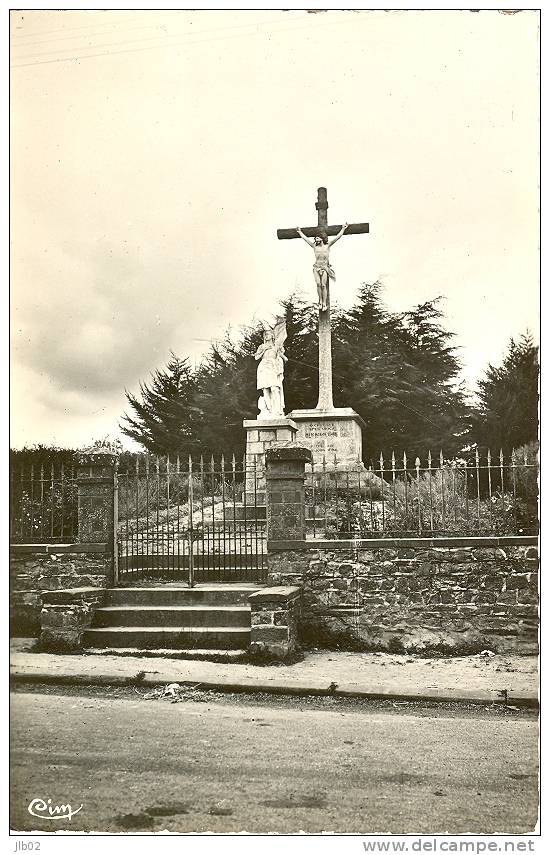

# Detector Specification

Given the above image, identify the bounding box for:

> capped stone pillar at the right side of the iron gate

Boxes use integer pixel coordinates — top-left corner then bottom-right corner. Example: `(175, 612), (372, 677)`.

(265, 445), (312, 548)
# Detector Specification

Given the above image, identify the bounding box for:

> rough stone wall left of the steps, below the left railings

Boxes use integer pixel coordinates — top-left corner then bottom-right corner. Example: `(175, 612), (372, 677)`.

(10, 543), (112, 637)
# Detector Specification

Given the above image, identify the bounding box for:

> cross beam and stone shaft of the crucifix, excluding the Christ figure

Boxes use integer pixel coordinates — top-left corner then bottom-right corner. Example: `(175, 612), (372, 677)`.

(277, 187), (369, 410)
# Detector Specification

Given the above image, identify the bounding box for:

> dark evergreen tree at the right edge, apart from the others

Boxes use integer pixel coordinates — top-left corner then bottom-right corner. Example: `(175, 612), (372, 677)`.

(471, 333), (539, 454)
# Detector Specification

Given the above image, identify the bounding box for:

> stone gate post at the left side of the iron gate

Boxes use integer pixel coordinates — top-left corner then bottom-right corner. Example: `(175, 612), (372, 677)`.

(76, 448), (118, 586)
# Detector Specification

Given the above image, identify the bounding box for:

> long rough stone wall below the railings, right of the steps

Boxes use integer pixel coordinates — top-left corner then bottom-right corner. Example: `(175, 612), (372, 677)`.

(268, 537), (538, 655)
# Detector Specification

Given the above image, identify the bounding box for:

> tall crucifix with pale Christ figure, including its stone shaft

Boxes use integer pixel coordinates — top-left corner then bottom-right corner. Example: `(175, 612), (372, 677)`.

(277, 187), (369, 410)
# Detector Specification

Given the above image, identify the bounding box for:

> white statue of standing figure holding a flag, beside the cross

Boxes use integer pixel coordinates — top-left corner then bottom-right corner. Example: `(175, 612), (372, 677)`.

(254, 318), (287, 419)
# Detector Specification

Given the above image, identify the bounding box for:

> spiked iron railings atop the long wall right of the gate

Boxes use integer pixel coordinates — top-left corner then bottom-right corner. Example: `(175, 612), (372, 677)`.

(306, 450), (538, 538)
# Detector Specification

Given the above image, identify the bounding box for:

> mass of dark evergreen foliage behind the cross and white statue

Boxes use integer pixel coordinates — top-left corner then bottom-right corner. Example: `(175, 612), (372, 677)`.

(121, 284), (470, 461)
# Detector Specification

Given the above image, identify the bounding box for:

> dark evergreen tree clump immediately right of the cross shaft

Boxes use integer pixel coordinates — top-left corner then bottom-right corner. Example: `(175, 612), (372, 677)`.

(333, 283), (470, 461)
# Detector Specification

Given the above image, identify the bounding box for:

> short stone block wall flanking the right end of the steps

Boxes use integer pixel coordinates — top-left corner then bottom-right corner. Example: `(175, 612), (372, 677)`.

(248, 585), (302, 659)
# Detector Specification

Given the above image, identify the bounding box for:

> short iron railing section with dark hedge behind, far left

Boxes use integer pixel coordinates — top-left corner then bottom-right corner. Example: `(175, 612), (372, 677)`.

(10, 462), (78, 543)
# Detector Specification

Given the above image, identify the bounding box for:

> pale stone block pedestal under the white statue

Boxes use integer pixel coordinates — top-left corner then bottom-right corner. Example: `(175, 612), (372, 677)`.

(243, 416), (298, 505)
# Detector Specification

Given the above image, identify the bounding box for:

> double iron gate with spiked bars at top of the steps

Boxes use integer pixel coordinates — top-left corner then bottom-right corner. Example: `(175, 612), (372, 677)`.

(114, 454), (267, 585)
